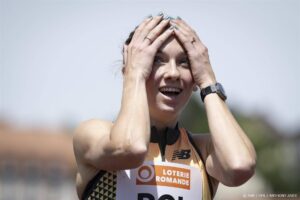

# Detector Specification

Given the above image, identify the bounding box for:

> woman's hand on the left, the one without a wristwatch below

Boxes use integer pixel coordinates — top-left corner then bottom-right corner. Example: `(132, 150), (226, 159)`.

(124, 16), (173, 80)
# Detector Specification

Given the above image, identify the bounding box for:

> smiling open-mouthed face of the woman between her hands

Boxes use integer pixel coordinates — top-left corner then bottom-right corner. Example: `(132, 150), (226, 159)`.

(146, 36), (195, 119)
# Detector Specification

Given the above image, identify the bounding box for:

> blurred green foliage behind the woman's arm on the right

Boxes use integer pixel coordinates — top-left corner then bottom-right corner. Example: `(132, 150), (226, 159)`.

(181, 98), (300, 199)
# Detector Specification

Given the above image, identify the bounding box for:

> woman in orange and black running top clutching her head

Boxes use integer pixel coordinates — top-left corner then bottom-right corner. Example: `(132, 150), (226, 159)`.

(73, 14), (256, 200)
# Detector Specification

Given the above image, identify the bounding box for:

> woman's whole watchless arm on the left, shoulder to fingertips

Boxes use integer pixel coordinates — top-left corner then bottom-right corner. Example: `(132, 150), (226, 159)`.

(74, 16), (173, 170)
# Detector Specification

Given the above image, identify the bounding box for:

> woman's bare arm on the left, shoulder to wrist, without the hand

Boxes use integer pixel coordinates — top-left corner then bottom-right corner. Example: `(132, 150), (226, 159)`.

(74, 74), (150, 170)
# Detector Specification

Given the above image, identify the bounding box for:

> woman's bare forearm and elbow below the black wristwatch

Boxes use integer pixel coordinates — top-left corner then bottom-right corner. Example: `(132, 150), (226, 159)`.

(204, 94), (256, 186)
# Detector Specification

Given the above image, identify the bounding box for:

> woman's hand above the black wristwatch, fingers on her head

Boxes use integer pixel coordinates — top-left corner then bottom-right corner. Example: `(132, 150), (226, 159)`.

(171, 19), (216, 89)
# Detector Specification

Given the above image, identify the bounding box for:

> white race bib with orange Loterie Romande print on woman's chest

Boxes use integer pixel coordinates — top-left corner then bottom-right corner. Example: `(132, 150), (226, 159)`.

(116, 161), (202, 200)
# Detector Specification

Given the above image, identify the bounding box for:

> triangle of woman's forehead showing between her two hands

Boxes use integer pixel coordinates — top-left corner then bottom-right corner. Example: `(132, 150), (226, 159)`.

(158, 36), (185, 56)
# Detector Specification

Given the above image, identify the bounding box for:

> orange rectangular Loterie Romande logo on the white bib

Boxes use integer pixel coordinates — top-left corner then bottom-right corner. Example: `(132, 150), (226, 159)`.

(136, 165), (191, 190)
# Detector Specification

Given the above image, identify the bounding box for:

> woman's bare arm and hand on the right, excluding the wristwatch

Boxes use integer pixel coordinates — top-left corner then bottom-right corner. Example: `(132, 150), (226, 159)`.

(173, 19), (256, 186)
